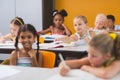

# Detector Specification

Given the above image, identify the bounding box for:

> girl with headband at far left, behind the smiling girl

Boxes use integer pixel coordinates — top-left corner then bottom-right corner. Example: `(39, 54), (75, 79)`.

(0, 17), (24, 43)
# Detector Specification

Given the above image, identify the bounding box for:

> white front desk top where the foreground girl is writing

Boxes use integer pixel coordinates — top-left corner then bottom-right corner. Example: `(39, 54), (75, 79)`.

(0, 65), (120, 80)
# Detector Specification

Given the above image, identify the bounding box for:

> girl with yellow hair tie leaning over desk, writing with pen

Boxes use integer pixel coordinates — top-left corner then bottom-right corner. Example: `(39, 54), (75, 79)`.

(59, 33), (120, 78)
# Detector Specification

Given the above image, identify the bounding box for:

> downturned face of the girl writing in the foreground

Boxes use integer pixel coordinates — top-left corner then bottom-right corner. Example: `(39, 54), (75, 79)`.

(88, 46), (109, 67)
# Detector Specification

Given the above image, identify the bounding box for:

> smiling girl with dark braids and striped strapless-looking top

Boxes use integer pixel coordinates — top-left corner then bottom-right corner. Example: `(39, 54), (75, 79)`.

(10, 24), (42, 67)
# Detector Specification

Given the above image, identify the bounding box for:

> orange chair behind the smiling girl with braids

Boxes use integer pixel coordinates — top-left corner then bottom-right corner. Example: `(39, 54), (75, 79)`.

(1, 51), (56, 68)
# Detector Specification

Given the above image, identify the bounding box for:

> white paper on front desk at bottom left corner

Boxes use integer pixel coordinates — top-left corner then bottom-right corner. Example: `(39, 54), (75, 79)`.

(0, 66), (20, 80)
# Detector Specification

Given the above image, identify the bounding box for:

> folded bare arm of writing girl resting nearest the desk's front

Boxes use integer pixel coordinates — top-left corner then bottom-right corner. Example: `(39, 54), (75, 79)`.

(81, 61), (120, 79)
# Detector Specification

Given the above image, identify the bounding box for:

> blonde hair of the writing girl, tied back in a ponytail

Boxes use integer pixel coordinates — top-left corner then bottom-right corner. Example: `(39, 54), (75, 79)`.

(89, 34), (120, 59)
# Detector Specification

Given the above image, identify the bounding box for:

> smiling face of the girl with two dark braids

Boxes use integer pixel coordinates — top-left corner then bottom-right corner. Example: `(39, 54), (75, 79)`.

(19, 31), (35, 49)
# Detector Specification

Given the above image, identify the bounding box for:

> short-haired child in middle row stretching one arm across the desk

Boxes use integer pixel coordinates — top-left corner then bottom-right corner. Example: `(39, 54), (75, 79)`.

(56, 15), (90, 43)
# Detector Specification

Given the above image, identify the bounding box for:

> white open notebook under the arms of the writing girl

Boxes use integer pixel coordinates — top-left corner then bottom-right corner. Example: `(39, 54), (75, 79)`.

(47, 69), (120, 80)
